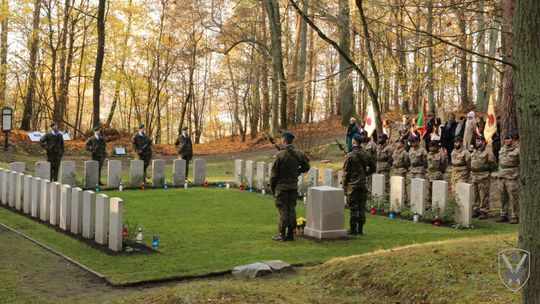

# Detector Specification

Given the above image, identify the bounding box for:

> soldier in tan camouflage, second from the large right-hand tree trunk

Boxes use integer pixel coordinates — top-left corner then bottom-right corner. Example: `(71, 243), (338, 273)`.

(471, 136), (497, 219)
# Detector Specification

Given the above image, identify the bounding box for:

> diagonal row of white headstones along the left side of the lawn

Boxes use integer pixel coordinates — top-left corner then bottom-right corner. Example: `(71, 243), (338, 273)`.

(0, 163), (124, 251)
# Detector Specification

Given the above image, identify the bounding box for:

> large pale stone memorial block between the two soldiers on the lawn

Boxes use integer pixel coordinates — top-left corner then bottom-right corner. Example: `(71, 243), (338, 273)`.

(304, 186), (347, 239)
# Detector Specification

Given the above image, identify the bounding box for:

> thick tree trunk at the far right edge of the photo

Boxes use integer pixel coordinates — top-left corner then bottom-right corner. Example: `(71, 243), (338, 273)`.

(516, 0), (540, 304)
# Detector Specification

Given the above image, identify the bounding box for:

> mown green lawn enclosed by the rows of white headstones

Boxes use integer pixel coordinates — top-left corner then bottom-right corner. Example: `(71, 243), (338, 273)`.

(0, 188), (517, 284)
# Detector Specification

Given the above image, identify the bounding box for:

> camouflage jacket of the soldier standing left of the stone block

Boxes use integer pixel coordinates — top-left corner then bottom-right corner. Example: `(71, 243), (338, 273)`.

(270, 145), (309, 193)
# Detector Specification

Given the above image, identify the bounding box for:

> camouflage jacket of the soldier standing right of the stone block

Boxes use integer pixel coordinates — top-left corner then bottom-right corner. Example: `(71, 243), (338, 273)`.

(343, 146), (375, 192)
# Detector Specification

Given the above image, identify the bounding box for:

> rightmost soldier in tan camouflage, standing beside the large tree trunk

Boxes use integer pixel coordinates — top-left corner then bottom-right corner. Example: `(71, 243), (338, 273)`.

(497, 134), (519, 224)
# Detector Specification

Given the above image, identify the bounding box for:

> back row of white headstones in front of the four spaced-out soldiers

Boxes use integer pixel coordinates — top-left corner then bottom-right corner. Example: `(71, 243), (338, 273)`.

(10, 159), (206, 189)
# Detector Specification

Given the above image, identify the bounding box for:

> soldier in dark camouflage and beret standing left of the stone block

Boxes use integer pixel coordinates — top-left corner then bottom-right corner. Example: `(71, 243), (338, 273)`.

(270, 132), (309, 242)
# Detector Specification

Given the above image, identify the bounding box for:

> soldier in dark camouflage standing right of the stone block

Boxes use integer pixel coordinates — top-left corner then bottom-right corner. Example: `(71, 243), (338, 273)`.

(343, 134), (375, 235)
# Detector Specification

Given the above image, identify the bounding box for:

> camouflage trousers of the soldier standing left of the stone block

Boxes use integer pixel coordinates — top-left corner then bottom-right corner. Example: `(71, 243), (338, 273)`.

(274, 189), (298, 237)
